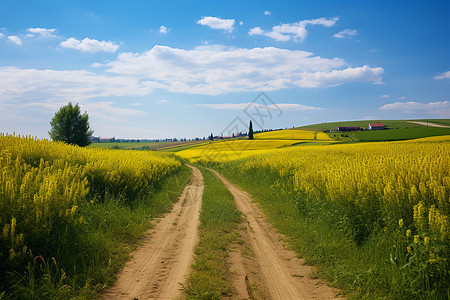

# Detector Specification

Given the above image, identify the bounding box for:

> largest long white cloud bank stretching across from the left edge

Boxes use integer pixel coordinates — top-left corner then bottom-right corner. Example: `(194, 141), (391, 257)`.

(0, 45), (383, 102)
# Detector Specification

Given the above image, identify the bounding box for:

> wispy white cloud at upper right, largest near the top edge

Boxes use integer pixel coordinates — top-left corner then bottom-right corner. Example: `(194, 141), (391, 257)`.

(249, 18), (339, 42)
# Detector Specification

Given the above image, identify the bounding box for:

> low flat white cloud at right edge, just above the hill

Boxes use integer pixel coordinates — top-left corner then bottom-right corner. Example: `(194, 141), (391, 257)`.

(380, 101), (450, 117)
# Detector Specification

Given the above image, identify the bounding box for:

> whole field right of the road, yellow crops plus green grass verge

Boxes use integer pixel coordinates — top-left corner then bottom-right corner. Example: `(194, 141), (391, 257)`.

(194, 136), (450, 299)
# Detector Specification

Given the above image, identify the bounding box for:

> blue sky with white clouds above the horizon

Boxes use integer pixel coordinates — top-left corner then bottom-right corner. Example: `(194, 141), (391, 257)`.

(0, 0), (450, 139)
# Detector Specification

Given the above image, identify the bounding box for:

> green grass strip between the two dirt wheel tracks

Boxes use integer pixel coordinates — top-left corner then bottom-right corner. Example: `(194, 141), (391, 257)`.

(185, 168), (241, 299)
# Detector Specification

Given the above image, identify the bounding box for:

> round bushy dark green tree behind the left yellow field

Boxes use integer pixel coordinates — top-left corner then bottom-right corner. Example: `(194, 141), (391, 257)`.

(48, 102), (93, 147)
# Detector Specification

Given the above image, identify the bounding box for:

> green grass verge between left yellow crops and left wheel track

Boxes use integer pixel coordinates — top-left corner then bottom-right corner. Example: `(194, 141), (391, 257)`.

(4, 166), (191, 299)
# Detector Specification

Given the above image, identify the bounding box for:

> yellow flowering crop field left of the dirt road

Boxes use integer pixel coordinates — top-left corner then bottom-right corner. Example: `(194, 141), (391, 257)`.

(0, 135), (181, 298)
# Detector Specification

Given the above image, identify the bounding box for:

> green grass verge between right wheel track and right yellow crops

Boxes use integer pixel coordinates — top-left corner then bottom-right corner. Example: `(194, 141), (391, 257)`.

(217, 163), (450, 299)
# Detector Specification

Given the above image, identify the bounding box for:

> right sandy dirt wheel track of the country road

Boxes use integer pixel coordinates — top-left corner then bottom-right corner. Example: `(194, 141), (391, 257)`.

(214, 171), (338, 300)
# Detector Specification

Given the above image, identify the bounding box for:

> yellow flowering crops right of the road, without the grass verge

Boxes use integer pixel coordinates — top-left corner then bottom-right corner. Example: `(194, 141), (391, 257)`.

(184, 136), (450, 298)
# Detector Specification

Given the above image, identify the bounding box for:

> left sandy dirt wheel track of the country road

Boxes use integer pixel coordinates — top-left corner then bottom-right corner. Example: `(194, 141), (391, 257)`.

(103, 166), (203, 300)
